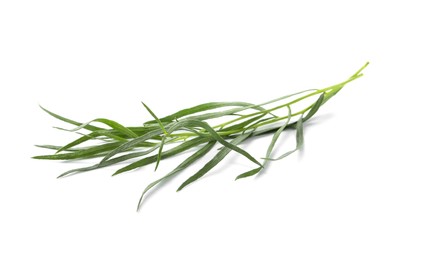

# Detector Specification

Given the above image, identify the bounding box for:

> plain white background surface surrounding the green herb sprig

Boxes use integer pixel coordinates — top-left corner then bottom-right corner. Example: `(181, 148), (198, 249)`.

(0, 0), (425, 260)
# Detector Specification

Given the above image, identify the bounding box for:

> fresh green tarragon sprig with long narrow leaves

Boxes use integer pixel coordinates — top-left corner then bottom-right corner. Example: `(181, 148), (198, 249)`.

(33, 63), (368, 210)
